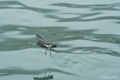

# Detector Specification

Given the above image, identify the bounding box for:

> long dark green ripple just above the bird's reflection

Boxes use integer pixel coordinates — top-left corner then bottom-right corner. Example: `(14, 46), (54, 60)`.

(0, 67), (75, 76)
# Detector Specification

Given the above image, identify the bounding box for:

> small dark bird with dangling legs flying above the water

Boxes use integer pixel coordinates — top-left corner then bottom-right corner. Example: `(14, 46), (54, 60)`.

(36, 34), (59, 57)
